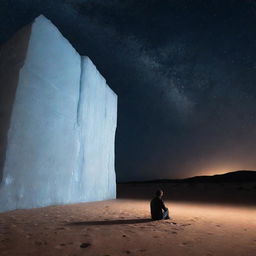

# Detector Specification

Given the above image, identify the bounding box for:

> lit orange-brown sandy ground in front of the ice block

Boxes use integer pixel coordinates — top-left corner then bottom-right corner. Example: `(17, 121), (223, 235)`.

(0, 199), (256, 256)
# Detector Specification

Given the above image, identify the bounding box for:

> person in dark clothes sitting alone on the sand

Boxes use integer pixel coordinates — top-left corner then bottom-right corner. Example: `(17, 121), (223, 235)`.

(150, 189), (170, 220)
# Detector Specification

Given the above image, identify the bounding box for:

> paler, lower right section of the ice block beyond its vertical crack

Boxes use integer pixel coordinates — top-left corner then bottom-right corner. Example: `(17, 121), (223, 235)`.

(78, 57), (117, 200)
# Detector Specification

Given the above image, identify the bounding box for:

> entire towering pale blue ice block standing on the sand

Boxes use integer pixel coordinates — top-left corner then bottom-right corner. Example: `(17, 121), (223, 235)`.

(0, 16), (117, 211)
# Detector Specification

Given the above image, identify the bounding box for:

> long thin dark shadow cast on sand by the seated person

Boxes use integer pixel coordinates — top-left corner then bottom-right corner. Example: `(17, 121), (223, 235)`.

(67, 219), (153, 226)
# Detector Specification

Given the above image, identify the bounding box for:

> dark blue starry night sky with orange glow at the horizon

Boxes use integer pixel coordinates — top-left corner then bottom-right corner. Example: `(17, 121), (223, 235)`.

(0, 0), (256, 181)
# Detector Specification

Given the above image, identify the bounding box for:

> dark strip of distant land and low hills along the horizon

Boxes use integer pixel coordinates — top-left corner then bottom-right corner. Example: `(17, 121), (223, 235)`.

(117, 170), (256, 205)
